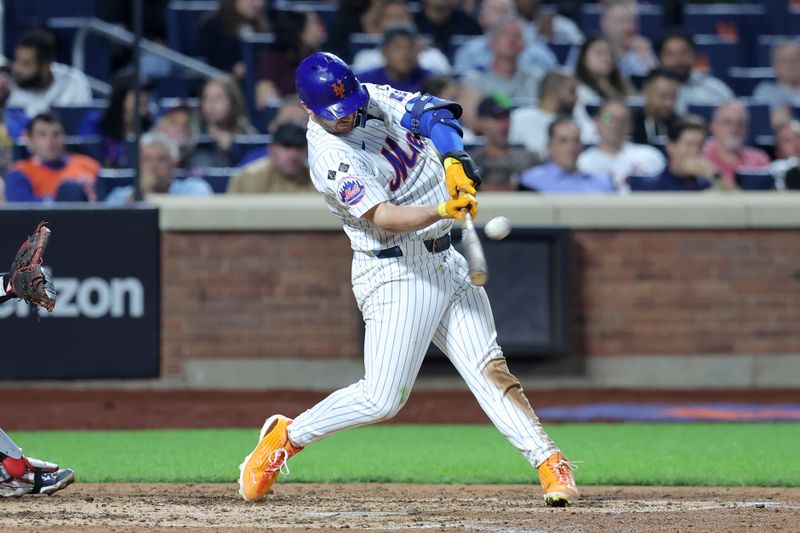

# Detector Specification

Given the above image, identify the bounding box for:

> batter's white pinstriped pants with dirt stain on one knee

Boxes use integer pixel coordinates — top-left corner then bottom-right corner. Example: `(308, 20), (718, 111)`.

(289, 242), (558, 467)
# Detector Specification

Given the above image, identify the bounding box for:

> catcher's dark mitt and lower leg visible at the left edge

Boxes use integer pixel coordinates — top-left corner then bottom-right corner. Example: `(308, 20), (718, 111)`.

(0, 222), (75, 496)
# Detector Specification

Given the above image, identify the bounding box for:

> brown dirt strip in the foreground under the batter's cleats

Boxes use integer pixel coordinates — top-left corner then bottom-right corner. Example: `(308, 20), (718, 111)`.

(0, 484), (800, 533)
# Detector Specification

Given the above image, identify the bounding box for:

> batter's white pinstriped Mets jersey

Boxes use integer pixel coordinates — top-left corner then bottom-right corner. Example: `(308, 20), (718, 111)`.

(307, 83), (452, 252)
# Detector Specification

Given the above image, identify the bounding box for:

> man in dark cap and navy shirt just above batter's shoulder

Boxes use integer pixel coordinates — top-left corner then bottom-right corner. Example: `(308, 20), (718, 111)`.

(357, 25), (433, 93)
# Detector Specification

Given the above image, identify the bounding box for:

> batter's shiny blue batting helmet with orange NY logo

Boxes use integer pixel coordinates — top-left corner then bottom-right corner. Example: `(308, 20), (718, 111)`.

(295, 52), (369, 120)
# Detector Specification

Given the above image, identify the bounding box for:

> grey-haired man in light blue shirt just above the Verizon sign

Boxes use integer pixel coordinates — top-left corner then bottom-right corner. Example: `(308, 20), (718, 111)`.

(105, 132), (214, 205)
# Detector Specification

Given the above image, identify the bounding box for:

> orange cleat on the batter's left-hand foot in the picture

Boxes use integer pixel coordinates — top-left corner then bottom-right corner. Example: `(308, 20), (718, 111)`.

(239, 415), (303, 502)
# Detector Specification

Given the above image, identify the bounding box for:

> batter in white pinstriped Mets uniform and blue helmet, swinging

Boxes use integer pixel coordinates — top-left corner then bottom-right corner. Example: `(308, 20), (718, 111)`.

(239, 53), (579, 507)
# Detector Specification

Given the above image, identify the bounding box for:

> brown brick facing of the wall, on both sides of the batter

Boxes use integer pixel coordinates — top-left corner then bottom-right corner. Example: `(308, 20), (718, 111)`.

(161, 230), (800, 376)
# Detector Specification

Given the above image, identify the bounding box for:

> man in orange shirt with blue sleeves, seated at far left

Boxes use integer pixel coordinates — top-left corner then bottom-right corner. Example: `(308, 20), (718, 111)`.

(6, 113), (100, 202)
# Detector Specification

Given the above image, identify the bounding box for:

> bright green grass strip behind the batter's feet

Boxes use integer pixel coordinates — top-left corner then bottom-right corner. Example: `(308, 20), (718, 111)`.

(11, 423), (800, 486)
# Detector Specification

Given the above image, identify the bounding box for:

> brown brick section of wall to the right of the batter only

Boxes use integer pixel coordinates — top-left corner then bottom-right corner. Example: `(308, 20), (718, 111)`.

(572, 230), (800, 355)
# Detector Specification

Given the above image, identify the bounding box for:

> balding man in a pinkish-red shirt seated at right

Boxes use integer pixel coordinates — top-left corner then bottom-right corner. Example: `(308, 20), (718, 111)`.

(703, 100), (770, 188)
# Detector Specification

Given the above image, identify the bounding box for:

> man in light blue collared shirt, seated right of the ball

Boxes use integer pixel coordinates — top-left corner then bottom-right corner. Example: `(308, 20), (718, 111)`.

(520, 117), (614, 194)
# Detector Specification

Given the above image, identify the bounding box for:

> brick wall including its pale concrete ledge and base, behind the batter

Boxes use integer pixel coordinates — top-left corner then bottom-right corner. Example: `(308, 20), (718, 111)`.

(153, 193), (800, 389)
